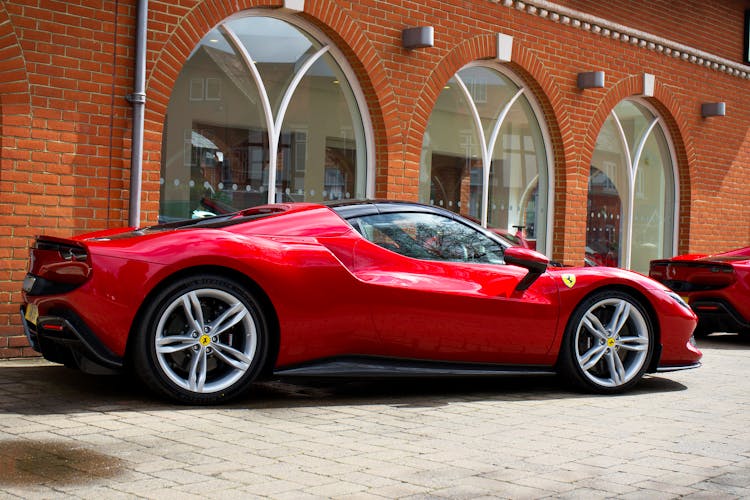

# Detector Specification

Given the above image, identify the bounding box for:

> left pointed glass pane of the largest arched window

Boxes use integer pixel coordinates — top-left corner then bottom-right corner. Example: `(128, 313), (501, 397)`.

(160, 30), (268, 220)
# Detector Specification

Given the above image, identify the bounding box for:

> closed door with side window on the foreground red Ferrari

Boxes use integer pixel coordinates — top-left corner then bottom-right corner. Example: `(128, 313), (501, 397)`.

(350, 212), (559, 365)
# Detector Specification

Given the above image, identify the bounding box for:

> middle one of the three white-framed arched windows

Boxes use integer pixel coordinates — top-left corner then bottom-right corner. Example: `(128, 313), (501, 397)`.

(420, 64), (552, 253)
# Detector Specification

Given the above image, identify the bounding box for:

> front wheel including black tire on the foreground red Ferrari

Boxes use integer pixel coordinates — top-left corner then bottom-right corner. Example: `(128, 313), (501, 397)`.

(558, 290), (656, 394)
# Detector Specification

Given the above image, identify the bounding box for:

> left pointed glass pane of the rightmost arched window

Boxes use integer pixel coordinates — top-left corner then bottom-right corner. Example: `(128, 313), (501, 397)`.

(586, 116), (630, 266)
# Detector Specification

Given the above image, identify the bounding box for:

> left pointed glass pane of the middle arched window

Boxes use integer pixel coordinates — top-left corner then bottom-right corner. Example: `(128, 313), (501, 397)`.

(420, 78), (482, 218)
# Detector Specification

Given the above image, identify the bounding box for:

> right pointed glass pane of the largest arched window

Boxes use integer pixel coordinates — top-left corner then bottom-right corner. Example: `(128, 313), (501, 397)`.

(276, 50), (365, 201)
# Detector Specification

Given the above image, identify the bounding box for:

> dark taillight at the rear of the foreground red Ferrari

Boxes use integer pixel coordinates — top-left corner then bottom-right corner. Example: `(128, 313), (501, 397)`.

(23, 238), (91, 295)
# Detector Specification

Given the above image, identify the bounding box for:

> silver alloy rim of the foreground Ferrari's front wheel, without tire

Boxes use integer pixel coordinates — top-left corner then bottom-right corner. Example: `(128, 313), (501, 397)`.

(573, 298), (651, 388)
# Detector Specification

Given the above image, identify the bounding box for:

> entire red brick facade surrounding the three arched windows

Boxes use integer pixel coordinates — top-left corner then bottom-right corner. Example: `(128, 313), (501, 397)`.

(0, 0), (750, 357)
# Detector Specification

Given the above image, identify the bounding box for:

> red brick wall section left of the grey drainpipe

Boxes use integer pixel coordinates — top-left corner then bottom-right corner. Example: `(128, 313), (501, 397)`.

(0, 0), (135, 357)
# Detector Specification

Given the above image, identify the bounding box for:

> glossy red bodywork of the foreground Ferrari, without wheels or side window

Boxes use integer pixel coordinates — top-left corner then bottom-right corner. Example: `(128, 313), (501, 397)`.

(22, 203), (701, 400)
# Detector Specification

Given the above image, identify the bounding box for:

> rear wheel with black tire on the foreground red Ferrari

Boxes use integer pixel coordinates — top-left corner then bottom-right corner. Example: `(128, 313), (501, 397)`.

(133, 275), (269, 404)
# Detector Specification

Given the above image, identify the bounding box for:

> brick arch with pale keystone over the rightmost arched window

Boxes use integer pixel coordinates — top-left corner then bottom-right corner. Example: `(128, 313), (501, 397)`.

(579, 75), (696, 253)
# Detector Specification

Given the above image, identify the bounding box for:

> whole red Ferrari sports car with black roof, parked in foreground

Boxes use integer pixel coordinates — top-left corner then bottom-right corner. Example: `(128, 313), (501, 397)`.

(21, 201), (701, 404)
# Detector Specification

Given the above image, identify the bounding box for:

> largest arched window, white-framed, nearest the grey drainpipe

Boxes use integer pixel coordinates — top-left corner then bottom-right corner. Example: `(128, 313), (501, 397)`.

(160, 13), (372, 220)
